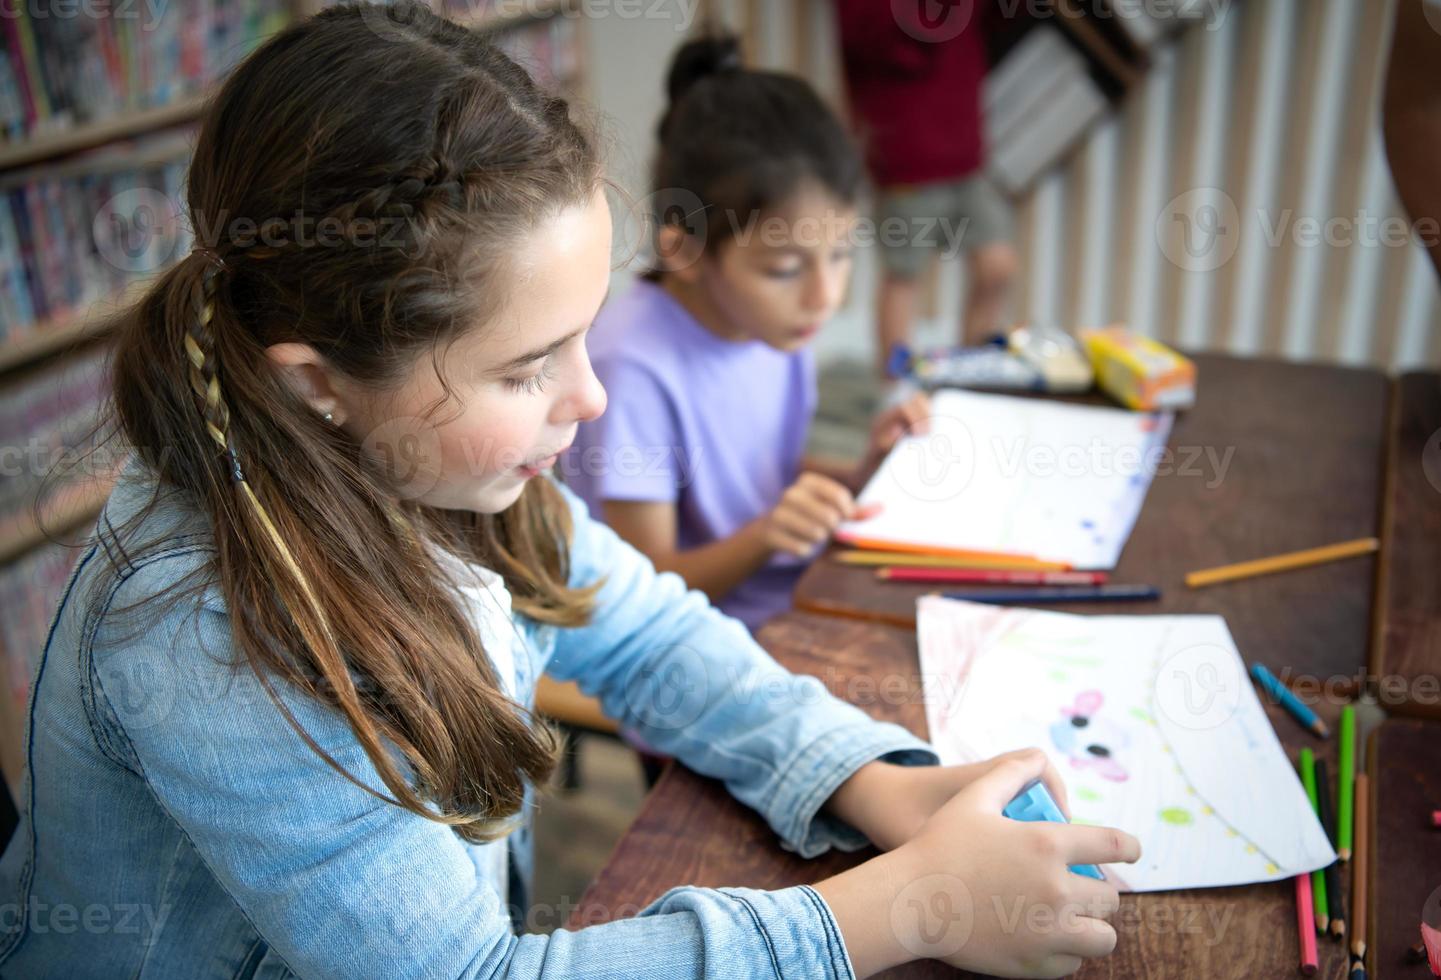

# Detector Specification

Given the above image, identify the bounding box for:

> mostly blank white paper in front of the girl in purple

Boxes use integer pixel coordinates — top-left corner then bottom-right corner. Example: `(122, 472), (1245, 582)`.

(837, 391), (1173, 569)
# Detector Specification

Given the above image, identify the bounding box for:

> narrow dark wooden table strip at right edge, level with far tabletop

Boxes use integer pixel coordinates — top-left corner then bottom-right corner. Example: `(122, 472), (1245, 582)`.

(1372, 373), (1441, 720)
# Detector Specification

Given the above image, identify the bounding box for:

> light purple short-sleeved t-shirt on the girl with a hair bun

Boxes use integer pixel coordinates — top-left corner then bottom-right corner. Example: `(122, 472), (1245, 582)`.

(556, 280), (816, 630)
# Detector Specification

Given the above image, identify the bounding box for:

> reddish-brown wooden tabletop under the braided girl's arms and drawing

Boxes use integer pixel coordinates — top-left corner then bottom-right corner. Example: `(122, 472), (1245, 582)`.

(571, 613), (1346, 980)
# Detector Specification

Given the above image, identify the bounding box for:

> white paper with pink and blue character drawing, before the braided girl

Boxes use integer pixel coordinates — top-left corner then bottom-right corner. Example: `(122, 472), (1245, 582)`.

(916, 597), (1336, 892)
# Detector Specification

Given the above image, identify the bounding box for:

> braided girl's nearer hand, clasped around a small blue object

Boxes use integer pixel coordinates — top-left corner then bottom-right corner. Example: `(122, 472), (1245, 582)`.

(892, 749), (1141, 977)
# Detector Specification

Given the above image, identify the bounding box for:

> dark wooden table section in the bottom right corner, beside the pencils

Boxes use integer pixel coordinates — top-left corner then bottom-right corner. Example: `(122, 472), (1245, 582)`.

(1366, 718), (1441, 980)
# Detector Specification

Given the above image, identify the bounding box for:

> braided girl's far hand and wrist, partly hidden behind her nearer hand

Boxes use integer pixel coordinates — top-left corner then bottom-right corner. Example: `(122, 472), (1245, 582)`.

(827, 749), (1071, 850)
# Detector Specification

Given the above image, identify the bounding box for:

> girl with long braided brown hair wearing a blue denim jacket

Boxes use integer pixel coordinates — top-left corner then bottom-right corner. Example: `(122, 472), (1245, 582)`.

(0, 3), (1136, 980)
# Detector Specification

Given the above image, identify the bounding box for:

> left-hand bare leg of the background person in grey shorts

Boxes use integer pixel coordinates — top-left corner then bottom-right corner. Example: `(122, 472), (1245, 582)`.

(876, 187), (940, 378)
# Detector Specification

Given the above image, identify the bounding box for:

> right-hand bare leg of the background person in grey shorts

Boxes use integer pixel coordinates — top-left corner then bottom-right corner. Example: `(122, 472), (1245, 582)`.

(955, 174), (1020, 344)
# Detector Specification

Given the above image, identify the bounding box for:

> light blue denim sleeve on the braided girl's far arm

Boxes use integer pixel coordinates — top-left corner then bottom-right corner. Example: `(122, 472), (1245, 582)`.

(546, 487), (940, 858)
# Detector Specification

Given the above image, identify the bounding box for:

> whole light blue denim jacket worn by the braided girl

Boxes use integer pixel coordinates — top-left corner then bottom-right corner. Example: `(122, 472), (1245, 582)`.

(0, 457), (938, 980)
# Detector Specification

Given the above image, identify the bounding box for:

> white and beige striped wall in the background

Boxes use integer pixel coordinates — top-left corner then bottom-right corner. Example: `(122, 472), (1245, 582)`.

(588, 0), (1441, 369)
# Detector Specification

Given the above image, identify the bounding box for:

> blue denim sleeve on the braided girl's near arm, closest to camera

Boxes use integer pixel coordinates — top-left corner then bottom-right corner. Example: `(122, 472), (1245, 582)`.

(87, 562), (853, 980)
